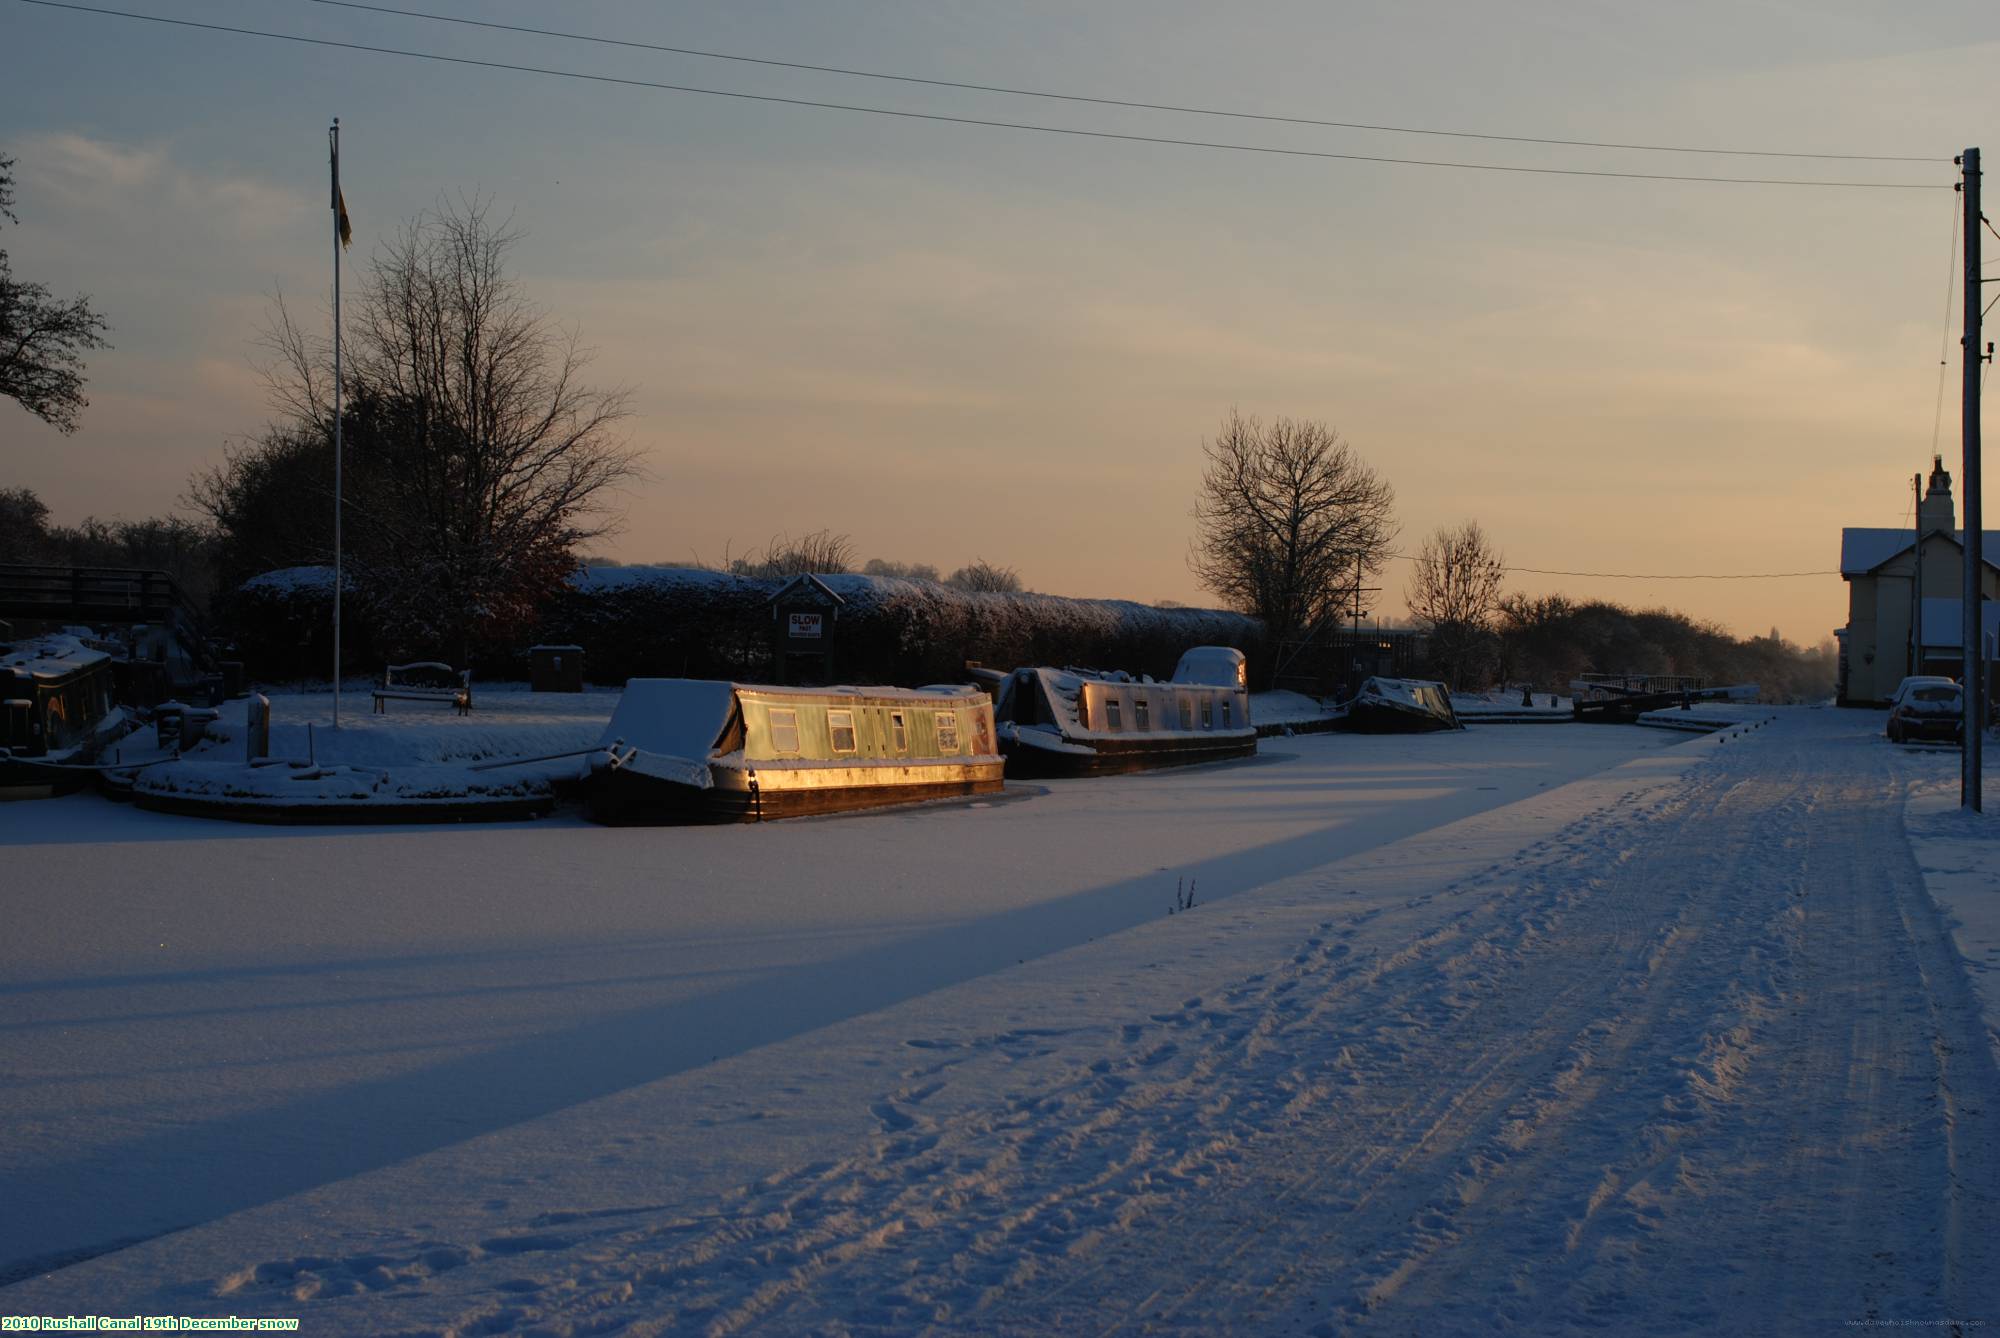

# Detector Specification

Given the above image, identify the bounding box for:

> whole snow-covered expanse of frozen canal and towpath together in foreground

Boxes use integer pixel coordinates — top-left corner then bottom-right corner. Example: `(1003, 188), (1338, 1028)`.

(0, 710), (2000, 1332)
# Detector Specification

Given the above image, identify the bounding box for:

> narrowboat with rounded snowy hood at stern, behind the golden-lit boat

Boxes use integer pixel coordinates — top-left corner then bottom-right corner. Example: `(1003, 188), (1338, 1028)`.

(988, 646), (1256, 776)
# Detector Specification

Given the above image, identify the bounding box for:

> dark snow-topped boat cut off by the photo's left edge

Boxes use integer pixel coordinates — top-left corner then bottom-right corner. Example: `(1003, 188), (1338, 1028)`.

(0, 632), (132, 798)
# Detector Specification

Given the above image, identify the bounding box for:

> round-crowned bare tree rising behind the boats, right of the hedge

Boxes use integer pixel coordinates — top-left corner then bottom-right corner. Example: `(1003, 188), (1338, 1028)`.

(1188, 410), (1396, 656)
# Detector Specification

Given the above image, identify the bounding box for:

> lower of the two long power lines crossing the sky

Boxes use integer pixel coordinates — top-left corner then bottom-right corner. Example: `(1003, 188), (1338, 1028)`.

(20, 0), (1946, 190)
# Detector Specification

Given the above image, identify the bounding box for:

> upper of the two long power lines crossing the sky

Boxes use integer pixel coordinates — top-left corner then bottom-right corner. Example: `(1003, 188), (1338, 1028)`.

(292, 0), (1946, 162)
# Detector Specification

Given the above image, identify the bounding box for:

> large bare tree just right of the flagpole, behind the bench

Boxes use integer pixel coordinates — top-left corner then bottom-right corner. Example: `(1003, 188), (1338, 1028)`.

(249, 198), (640, 656)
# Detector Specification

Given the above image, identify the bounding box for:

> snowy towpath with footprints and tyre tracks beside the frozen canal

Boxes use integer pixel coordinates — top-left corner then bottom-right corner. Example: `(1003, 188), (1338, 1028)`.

(15, 712), (2000, 1334)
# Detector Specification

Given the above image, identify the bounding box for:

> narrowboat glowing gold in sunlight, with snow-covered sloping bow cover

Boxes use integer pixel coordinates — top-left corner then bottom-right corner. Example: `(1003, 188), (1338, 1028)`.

(584, 678), (1002, 826)
